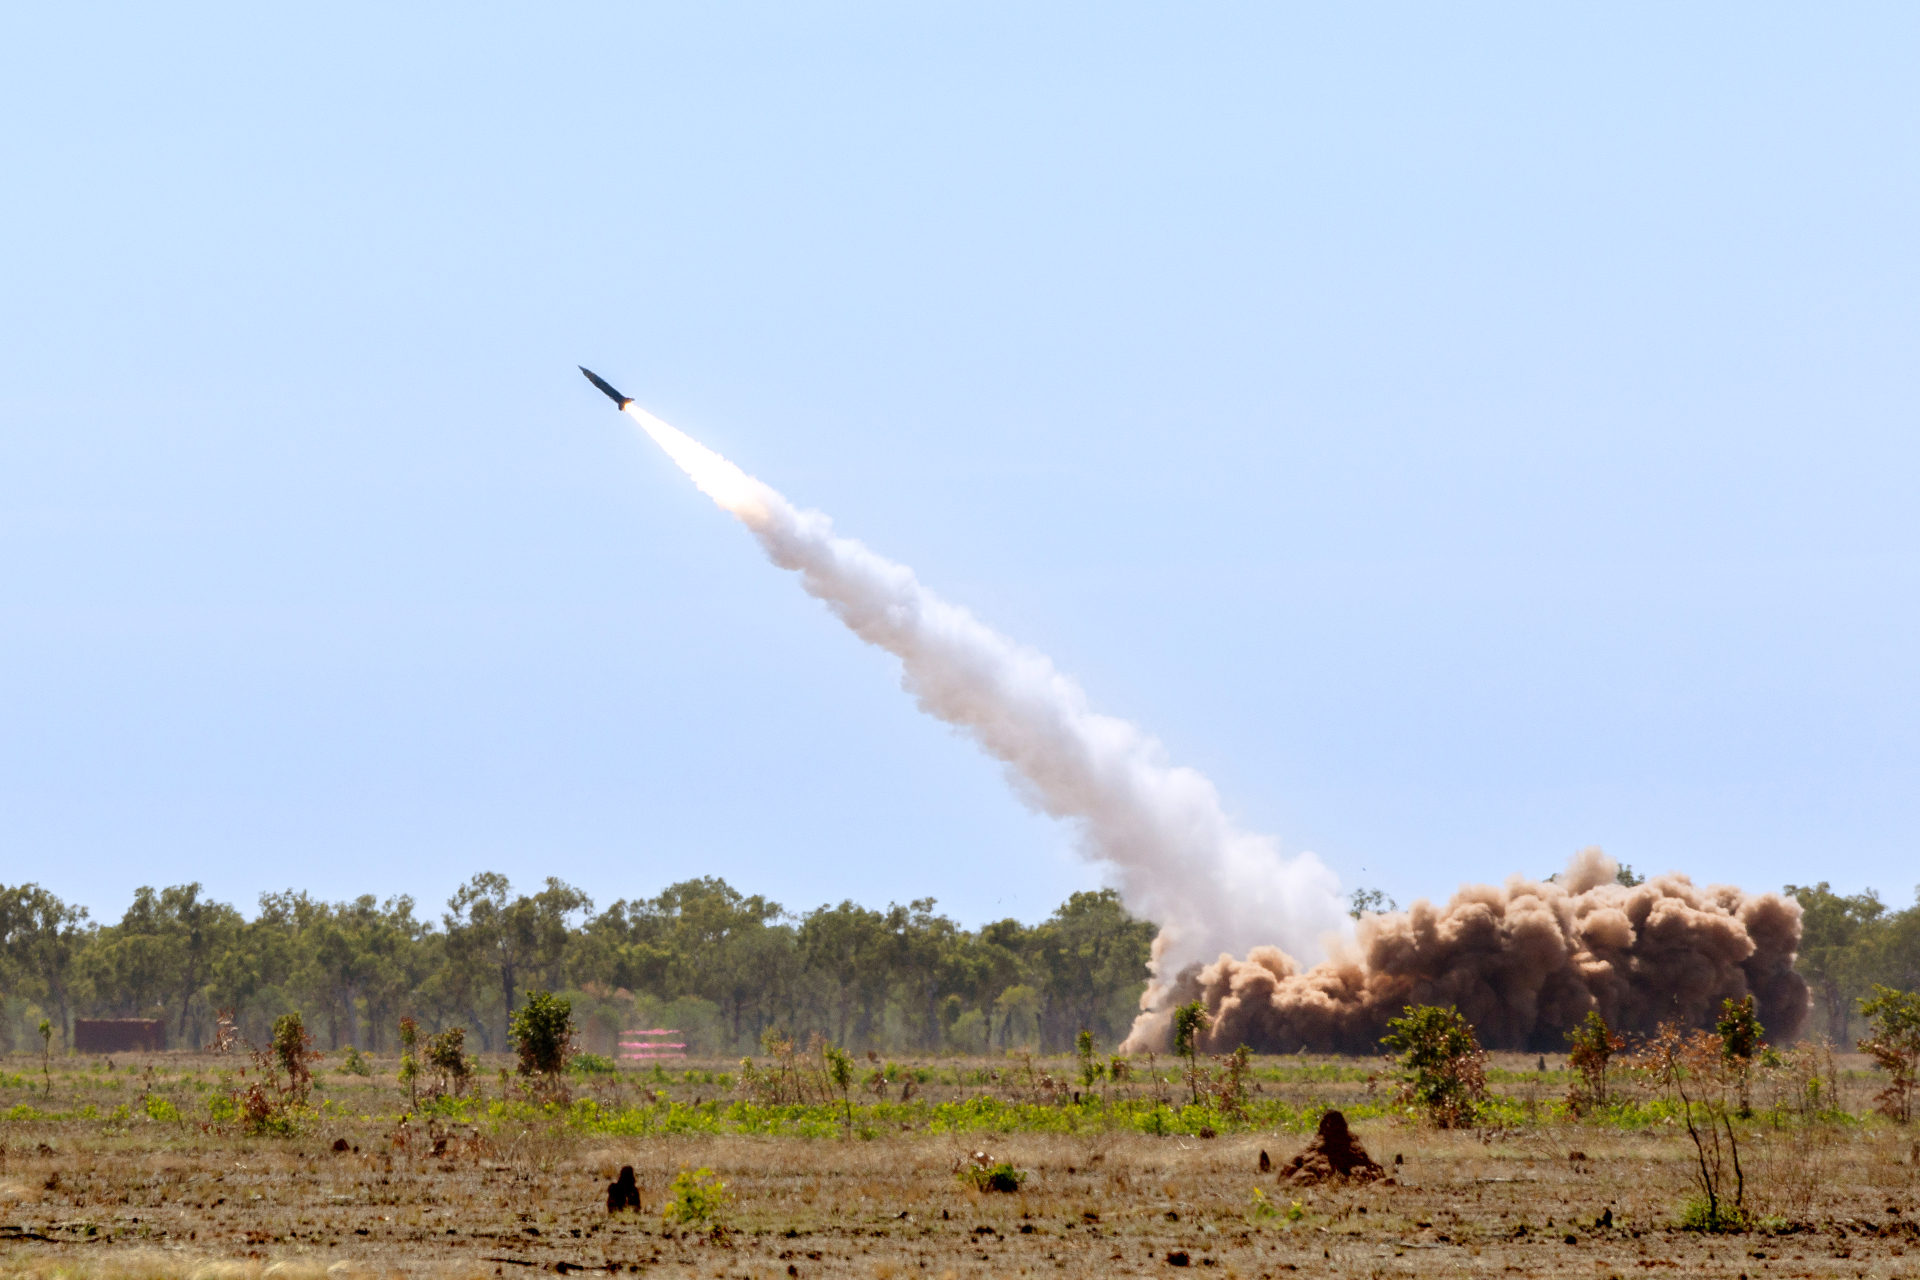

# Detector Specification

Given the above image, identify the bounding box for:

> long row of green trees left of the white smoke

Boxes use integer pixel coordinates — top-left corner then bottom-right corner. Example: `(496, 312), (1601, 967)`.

(0, 871), (1156, 1054)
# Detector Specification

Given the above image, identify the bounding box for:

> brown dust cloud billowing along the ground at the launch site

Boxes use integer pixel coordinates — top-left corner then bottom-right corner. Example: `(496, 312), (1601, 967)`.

(1127, 848), (1809, 1054)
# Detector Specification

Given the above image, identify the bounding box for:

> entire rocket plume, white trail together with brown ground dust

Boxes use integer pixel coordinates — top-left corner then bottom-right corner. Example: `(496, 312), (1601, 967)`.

(624, 403), (1807, 1054)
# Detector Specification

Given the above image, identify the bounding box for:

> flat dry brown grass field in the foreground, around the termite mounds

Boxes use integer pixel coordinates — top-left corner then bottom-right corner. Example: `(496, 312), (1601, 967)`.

(0, 1054), (1920, 1280)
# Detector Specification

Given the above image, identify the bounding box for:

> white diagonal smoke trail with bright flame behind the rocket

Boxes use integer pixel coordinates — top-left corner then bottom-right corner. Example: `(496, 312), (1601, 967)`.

(626, 403), (1346, 1020)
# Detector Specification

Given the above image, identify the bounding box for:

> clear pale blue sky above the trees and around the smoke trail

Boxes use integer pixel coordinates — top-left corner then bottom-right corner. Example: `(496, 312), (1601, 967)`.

(0, 4), (1920, 923)
